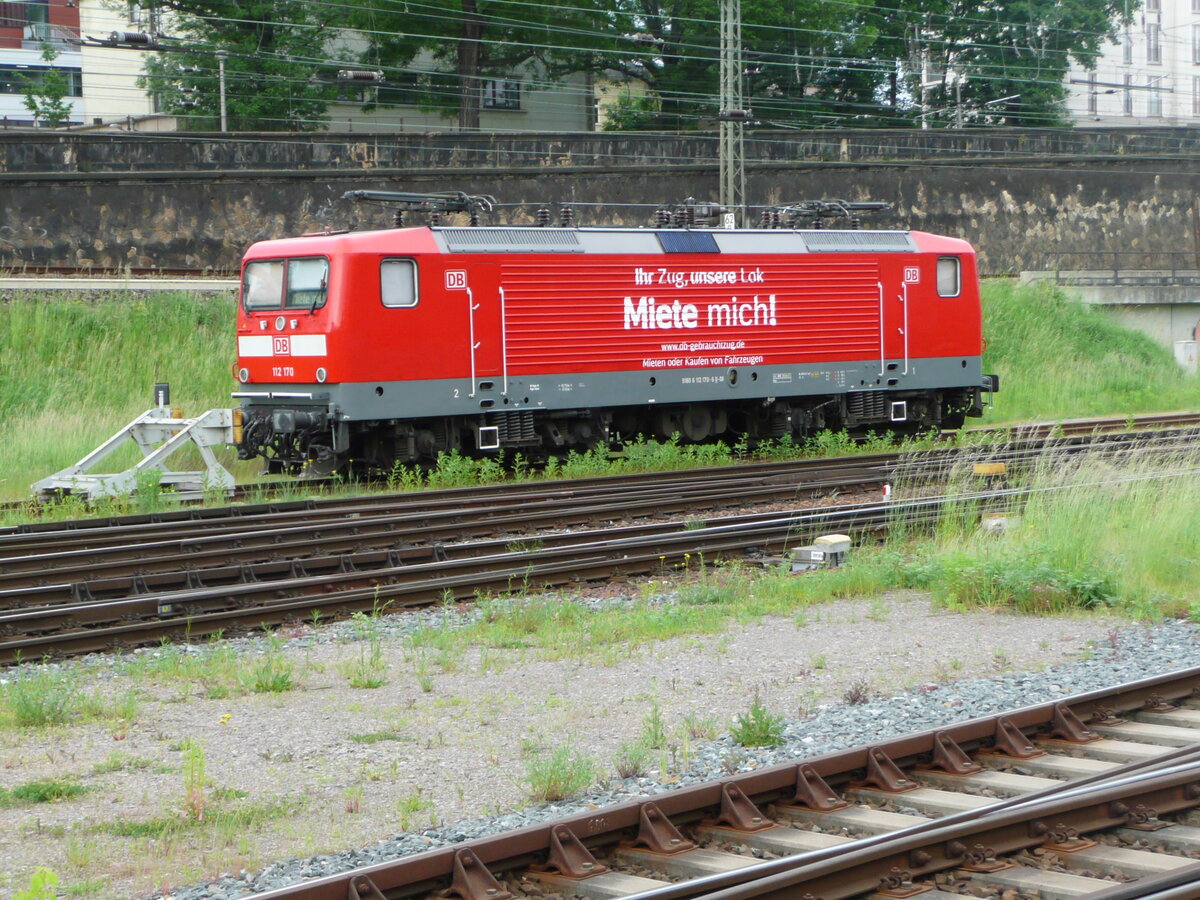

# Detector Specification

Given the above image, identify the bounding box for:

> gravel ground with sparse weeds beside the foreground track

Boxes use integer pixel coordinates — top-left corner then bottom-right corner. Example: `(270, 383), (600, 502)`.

(0, 588), (1185, 900)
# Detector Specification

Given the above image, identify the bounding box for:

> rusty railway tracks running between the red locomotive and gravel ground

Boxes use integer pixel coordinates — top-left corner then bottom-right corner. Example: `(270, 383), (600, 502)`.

(0, 432), (1194, 662)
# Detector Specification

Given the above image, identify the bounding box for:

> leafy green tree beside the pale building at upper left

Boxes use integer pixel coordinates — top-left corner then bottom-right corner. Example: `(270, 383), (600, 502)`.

(139, 0), (341, 131)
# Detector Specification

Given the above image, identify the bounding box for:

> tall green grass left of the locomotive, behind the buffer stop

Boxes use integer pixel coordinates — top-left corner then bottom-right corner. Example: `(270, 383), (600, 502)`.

(0, 293), (234, 497)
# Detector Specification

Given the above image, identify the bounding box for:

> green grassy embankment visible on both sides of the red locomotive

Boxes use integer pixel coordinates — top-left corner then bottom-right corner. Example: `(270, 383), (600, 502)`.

(0, 282), (1196, 508)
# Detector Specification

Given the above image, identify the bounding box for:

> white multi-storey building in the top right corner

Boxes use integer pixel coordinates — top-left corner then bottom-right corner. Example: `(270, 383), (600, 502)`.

(1067, 0), (1200, 127)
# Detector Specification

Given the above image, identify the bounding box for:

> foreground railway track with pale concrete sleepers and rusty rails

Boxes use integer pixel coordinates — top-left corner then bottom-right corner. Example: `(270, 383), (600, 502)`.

(231, 668), (1200, 900)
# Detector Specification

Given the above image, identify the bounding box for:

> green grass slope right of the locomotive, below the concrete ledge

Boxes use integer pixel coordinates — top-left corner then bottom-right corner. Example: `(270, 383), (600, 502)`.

(983, 280), (1200, 422)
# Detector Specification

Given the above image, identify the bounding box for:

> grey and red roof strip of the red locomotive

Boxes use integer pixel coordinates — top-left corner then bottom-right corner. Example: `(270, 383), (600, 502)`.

(247, 226), (973, 258)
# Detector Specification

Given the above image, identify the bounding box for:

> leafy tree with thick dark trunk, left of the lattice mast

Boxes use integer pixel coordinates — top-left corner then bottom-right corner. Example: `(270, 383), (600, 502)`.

(350, 0), (634, 131)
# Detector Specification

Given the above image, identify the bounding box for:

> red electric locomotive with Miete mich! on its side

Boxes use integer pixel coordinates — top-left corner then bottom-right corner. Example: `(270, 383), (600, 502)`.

(234, 195), (997, 473)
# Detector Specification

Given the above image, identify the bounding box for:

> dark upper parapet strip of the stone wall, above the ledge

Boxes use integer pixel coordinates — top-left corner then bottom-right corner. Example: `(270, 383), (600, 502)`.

(0, 127), (1200, 175)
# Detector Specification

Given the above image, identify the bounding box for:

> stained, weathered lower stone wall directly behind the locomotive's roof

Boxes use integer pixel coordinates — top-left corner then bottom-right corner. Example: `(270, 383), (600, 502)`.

(0, 132), (1200, 274)
